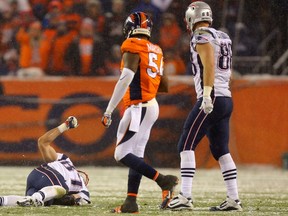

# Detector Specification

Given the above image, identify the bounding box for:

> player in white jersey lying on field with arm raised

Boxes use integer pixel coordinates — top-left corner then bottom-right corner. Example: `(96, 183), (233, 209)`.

(0, 116), (90, 207)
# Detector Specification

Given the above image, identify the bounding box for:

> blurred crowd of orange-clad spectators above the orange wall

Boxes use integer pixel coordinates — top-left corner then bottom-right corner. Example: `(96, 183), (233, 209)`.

(0, 0), (286, 77)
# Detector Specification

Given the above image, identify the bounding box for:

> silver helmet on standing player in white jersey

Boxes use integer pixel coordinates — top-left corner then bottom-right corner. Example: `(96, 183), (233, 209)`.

(185, 1), (213, 32)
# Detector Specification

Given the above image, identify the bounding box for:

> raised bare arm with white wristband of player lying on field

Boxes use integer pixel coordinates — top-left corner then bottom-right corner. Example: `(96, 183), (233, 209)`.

(38, 116), (78, 163)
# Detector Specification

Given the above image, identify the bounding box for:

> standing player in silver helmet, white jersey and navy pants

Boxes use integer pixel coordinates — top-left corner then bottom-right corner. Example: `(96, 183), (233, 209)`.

(168, 1), (242, 211)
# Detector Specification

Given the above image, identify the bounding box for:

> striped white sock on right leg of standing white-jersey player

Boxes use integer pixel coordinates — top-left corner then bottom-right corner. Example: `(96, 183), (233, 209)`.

(218, 153), (239, 200)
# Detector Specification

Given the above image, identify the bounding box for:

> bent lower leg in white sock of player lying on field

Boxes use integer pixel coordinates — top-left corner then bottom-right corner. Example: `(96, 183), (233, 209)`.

(32, 185), (66, 202)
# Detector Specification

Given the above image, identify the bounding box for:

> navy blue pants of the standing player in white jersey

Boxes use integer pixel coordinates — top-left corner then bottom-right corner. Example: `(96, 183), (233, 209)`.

(178, 97), (233, 160)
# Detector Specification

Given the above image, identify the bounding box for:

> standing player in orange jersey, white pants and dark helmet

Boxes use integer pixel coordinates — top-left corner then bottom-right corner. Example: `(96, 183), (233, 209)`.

(102, 12), (178, 213)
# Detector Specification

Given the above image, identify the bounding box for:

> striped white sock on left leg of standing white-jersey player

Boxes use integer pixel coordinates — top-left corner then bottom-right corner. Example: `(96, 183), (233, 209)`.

(180, 151), (196, 198)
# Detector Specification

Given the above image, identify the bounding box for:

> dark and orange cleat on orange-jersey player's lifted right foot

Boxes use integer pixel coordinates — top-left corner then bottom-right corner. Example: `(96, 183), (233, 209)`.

(159, 175), (179, 209)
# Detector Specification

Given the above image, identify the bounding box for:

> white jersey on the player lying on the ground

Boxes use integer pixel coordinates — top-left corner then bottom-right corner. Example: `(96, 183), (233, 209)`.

(47, 153), (90, 200)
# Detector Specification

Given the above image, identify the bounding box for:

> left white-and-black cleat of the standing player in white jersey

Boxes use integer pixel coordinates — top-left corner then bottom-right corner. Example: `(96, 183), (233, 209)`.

(167, 193), (193, 211)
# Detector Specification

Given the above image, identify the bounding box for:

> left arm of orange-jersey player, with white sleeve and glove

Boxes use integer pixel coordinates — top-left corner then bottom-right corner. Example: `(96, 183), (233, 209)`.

(102, 52), (140, 128)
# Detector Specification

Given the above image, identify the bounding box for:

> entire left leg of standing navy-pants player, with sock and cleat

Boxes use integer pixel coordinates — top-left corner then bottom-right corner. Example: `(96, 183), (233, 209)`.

(168, 101), (210, 210)
